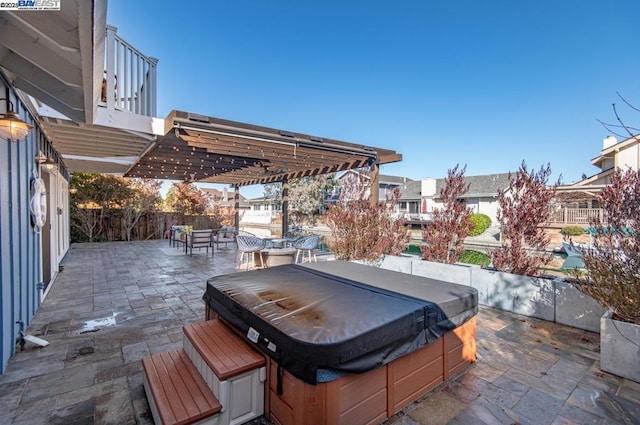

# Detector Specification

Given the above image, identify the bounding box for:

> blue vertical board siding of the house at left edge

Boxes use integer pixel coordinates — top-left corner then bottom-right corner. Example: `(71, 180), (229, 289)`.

(0, 75), (63, 373)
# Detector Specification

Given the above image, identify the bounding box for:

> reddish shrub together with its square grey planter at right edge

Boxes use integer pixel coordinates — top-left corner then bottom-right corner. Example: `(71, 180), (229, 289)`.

(576, 170), (640, 382)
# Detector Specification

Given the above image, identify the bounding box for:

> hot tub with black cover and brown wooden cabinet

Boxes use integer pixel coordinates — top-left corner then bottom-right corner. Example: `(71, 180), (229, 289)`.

(204, 261), (477, 425)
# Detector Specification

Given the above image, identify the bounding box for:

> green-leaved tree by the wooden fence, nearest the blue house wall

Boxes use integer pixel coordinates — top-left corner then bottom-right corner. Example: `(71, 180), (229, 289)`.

(70, 173), (131, 242)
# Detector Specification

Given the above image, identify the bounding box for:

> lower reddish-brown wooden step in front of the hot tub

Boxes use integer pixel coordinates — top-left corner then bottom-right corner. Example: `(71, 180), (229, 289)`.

(142, 349), (222, 425)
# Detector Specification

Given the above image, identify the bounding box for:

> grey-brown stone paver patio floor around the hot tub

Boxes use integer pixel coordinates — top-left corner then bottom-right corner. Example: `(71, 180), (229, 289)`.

(0, 240), (640, 425)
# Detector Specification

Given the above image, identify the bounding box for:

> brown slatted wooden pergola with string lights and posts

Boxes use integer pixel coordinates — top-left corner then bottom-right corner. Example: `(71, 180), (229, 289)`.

(125, 111), (402, 234)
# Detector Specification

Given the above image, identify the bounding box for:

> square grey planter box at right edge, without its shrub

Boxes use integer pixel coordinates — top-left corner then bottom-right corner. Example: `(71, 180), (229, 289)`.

(600, 311), (640, 382)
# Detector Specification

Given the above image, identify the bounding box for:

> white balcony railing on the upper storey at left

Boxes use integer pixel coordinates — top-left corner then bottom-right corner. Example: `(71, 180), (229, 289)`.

(101, 25), (158, 117)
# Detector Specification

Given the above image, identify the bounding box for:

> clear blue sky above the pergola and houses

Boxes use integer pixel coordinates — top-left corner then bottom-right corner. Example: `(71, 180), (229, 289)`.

(107, 0), (640, 197)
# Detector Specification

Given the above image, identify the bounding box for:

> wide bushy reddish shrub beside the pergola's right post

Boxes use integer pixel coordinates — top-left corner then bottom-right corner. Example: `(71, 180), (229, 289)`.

(326, 170), (411, 261)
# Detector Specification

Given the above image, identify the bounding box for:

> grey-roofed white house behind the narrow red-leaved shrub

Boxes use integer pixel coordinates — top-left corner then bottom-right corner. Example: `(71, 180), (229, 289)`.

(398, 173), (510, 223)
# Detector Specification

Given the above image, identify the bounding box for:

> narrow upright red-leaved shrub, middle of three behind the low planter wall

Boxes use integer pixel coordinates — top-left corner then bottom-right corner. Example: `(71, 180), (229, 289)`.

(420, 164), (473, 264)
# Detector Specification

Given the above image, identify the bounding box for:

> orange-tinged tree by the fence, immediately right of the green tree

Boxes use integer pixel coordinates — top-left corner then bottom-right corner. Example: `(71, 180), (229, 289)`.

(122, 179), (162, 241)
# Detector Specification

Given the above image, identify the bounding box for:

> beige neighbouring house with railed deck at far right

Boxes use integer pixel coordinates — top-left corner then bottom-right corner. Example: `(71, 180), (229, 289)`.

(551, 135), (640, 227)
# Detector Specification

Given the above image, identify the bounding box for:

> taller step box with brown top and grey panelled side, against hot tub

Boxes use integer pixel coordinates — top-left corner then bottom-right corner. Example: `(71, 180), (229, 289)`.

(183, 319), (266, 425)
